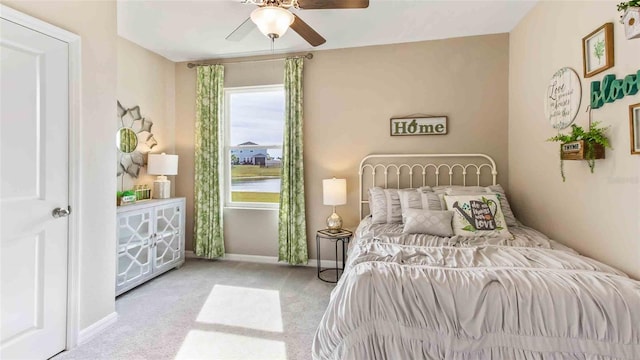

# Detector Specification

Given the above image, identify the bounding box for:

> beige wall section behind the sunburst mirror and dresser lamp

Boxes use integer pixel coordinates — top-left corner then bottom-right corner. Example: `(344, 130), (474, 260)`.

(114, 37), (180, 189)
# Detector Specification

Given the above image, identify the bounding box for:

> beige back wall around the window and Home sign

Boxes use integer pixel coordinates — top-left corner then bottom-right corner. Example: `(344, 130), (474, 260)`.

(176, 34), (509, 259)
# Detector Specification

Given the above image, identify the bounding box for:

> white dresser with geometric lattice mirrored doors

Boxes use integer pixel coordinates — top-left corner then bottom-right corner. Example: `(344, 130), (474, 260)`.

(116, 198), (185, 295)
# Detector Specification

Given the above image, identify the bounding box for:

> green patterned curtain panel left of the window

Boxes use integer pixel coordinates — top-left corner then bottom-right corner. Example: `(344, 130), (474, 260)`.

(193, 65), (224, 259)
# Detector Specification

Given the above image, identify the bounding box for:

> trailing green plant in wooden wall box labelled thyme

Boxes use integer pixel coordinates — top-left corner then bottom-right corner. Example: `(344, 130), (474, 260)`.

(547, 121), (611, 182)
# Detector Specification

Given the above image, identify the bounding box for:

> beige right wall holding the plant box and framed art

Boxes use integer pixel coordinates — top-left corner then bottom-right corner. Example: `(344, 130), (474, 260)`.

(509, 1), (640, 278)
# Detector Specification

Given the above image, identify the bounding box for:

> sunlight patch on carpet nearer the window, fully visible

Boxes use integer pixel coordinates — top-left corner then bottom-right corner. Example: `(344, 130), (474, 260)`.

(196, 285), (282, 332)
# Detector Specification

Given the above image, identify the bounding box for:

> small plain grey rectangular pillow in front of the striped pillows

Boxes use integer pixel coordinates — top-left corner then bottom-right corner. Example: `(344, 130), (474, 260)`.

(404, 209), (454, 237)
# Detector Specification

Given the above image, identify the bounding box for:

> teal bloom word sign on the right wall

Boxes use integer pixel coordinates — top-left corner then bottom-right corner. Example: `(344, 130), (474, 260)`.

(591, 70), (640, 109)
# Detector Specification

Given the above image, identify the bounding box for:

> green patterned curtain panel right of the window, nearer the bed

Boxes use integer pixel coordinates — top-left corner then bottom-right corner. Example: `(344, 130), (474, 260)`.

(278, 58), (309, 265)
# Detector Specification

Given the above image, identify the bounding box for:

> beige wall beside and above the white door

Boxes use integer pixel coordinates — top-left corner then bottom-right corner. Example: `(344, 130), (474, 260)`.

(3, 1), (117, 329)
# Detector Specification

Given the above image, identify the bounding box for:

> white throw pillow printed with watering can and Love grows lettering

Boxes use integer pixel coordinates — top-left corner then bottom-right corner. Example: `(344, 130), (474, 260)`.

(444, 194), (512, 238)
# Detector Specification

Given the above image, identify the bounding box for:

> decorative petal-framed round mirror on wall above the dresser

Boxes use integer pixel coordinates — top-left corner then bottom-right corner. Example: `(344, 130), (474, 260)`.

(116, 101), (158, 182)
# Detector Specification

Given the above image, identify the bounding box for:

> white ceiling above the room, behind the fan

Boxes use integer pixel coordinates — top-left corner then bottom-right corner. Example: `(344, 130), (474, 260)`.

(118, 0), (536, 61)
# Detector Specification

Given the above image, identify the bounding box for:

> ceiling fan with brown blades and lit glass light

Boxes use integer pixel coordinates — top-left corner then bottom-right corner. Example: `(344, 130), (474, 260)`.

(226, 0), (369, 46)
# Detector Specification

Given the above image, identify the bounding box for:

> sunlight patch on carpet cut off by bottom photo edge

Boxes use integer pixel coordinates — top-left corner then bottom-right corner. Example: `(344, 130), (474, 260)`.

(175, 330), (287, 360)
